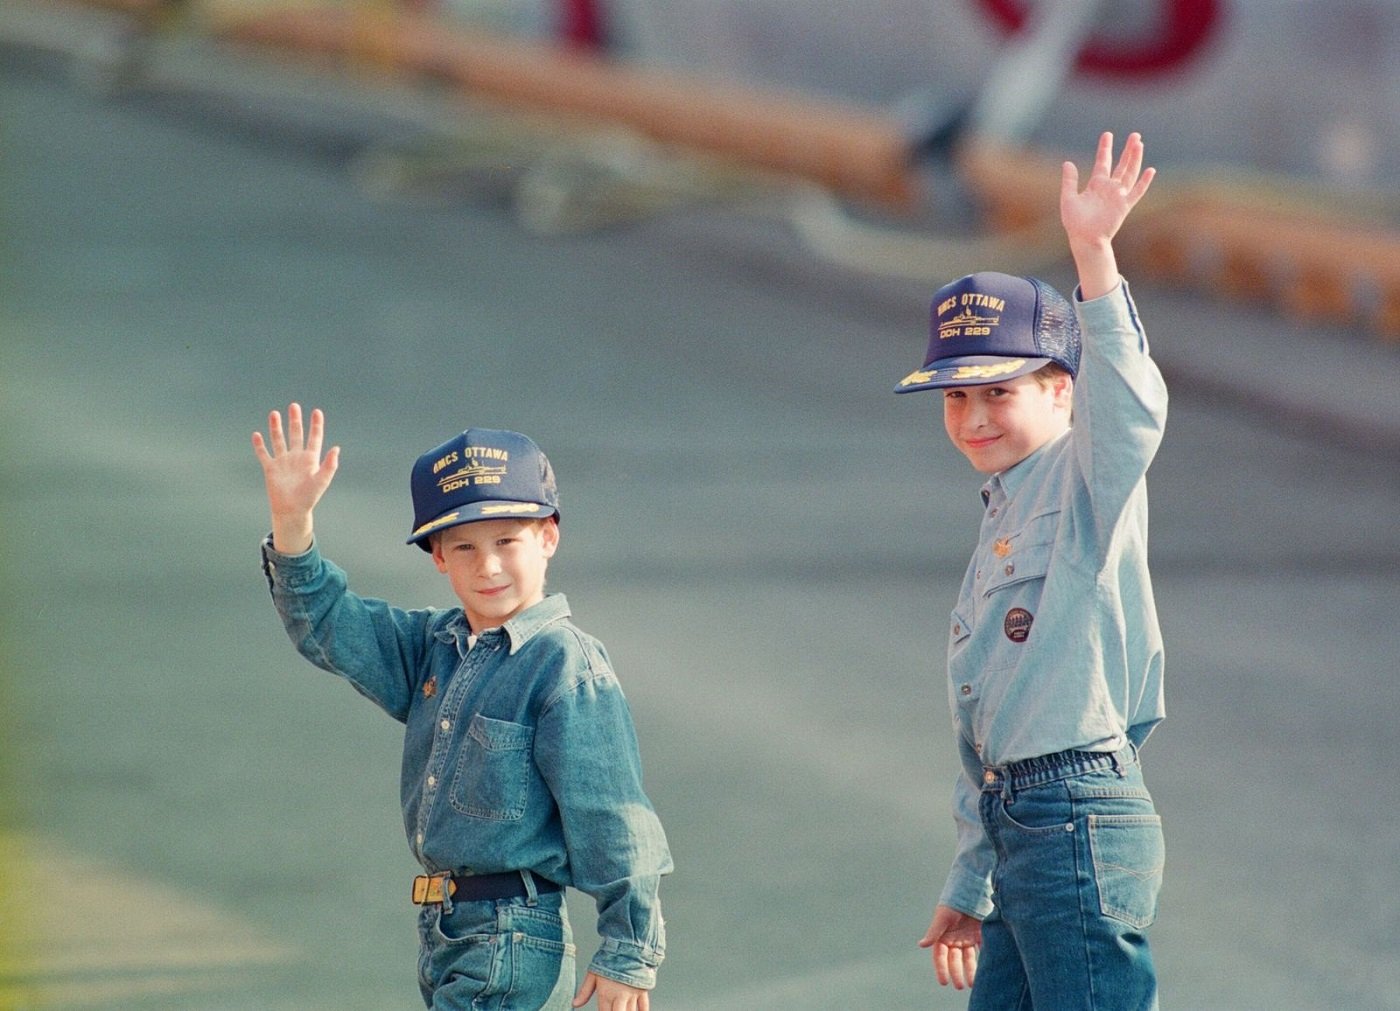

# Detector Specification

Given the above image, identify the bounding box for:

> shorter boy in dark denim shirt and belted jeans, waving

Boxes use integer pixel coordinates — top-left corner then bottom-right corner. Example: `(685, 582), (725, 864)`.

(253, 403), (672, 1011)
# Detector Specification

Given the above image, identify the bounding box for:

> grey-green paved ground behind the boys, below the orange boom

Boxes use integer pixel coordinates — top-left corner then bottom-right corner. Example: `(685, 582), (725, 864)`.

(0, 15), (1400, 1011)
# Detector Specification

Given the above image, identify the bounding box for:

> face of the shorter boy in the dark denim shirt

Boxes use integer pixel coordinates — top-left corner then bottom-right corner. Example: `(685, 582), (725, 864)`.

(433, 520), (559, 633)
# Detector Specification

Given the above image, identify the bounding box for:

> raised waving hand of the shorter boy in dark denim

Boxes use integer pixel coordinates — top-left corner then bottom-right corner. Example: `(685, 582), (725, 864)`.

(253, 403), (340, 555)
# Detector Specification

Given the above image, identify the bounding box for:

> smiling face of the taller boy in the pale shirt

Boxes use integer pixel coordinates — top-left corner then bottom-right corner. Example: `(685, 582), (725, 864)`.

(944, 372), (1074, 475)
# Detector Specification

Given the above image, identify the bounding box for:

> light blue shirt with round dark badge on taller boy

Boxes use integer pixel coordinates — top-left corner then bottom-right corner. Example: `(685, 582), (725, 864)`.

(939, 281), (1166, 917)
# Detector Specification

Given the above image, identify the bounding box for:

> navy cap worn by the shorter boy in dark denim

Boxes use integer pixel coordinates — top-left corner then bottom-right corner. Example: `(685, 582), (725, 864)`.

(407, 428), (559, 552)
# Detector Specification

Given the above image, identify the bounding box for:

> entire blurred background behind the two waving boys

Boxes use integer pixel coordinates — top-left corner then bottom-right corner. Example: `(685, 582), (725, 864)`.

(0, 0), (1400, 1011)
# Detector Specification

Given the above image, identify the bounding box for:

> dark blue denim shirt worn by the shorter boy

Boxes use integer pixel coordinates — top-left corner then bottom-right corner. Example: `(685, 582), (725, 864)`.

(263, 538), (672, 989)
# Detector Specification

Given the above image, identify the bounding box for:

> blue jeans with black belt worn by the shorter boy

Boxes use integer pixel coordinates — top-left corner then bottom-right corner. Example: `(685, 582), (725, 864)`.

(419, 892), (574, 1011)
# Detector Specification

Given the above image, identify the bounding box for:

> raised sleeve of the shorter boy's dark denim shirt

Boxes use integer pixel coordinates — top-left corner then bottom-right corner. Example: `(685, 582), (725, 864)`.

(262, 536), (430, 723)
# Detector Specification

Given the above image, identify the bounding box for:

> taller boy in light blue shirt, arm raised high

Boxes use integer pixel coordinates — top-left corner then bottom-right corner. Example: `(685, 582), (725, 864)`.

(896, 133), (1166, 1011)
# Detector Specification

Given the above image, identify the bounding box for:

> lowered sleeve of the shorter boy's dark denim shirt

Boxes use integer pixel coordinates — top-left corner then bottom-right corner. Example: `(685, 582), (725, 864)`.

(535, 653), (672, 989)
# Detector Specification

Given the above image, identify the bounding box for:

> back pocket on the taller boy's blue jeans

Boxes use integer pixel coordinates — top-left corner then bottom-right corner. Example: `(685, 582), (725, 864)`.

(1089, 815), (1166, 930)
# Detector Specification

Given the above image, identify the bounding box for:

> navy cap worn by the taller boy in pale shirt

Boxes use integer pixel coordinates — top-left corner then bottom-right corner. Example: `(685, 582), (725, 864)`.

(895, 270), (1079, 393)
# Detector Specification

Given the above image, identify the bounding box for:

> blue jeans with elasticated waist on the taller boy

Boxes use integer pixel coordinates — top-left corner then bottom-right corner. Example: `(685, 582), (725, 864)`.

(969, 748), (1166, 1011)
